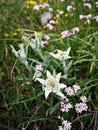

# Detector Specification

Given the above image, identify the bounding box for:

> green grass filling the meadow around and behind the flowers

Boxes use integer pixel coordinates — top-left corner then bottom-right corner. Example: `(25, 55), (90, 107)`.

(0, 0), (98, 130)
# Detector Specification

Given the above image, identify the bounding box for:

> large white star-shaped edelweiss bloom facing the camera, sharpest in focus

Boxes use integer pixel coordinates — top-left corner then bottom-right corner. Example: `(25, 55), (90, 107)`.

(36, 71), (66, 98)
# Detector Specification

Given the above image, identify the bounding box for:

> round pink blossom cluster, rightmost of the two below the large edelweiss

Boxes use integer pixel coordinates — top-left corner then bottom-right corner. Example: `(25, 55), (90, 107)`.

(75, 102), (88, 113)
